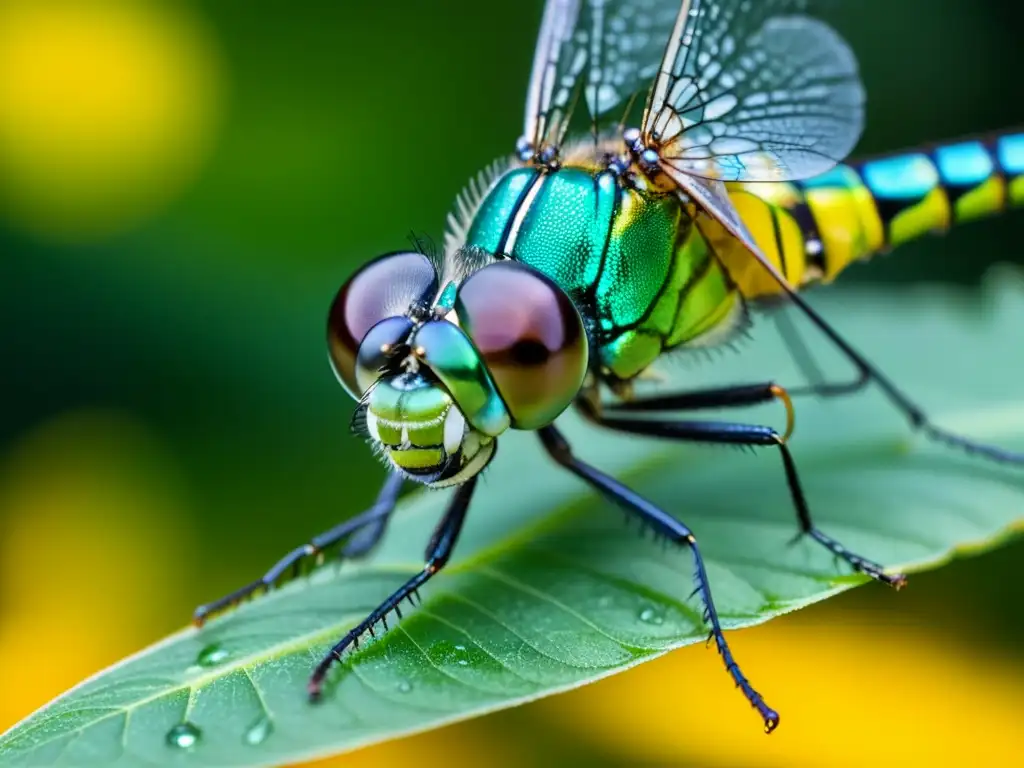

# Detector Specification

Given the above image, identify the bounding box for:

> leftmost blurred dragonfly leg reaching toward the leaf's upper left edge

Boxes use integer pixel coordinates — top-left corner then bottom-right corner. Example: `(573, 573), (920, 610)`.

(193, 474), (403, 627)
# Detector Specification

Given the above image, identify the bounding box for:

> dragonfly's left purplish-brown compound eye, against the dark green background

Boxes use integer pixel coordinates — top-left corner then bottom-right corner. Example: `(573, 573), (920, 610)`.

(327, 252), (437, 398)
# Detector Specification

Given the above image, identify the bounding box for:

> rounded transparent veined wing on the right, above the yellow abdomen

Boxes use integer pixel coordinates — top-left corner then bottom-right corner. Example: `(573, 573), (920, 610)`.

(643, 0), (864, 181)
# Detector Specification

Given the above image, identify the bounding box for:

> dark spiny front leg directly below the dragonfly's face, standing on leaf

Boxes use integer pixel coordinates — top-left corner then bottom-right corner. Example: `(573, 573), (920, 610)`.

(307, 476), (477, 700)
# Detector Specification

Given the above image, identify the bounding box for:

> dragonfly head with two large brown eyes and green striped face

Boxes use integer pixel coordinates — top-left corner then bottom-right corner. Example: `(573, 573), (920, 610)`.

(328, 252), (588, 486)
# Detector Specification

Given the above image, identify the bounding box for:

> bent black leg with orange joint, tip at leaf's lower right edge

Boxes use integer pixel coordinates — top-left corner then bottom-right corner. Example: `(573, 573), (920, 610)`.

(579, 383), (906, 589)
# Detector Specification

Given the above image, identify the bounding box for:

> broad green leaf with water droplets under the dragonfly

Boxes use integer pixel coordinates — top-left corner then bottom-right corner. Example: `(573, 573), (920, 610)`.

(0, 272), (1024, 766)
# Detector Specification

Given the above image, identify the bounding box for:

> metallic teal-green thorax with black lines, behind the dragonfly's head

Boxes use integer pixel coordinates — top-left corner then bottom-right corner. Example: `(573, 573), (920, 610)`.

(465, 166), (740, 380)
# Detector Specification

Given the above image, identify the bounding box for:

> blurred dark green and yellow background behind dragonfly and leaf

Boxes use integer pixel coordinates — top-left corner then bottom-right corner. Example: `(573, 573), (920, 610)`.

(0, 0), (1024, 766)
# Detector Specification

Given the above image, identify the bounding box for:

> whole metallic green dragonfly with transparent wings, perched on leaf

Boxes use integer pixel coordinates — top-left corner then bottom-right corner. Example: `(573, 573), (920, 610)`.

(195, 0), (1024, 733)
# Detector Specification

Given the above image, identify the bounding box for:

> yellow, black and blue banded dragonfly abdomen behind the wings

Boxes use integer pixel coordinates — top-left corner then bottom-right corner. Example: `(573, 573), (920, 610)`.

(726, 133), (1024, 298)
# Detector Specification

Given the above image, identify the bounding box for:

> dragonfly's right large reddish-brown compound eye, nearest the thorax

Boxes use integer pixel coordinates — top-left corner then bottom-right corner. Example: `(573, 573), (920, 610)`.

(456, 261), (588, 429)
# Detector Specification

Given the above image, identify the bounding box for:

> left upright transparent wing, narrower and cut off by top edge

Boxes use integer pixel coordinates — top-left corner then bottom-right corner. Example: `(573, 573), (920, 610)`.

(523, 0), (680, 151)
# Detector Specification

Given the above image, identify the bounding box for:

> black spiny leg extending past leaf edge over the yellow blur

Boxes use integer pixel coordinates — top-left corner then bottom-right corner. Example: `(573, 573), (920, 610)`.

(539, 427), (779, 733)
